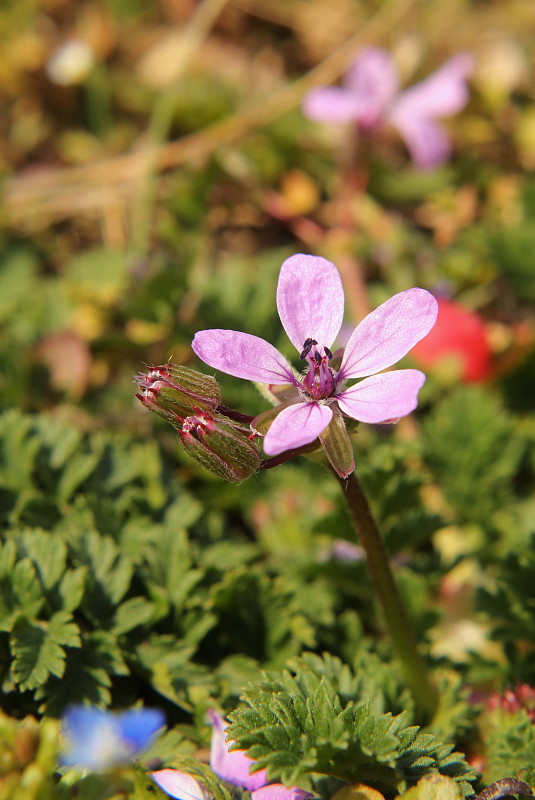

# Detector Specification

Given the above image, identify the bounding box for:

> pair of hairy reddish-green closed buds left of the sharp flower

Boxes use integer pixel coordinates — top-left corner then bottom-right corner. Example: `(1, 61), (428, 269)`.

(136, 363), (260, 483)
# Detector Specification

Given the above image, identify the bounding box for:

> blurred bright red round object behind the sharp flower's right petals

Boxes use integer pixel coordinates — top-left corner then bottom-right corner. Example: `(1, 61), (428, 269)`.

(411, 298), (492, 383)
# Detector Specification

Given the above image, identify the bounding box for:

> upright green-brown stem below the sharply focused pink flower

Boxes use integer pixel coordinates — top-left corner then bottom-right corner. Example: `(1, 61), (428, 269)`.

(335, 472), (438, 719)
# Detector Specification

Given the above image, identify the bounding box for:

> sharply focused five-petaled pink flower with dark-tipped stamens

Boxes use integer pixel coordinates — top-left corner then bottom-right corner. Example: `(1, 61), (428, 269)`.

(192, 255), (437, 477)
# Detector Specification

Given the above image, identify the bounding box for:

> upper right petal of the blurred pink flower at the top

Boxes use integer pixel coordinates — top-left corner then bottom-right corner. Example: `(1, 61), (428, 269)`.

(390, 53), (474, 121)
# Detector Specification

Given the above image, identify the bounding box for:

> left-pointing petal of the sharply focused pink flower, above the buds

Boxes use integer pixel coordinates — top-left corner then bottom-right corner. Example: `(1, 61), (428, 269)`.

(191, 328), (295, 384)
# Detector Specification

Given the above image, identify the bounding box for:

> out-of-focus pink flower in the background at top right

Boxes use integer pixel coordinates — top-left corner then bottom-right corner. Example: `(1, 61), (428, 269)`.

(303, 47), (474, 169)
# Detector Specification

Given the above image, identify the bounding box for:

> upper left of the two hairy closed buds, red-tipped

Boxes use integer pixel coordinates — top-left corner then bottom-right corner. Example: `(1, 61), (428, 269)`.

(136, 364), (221, 426)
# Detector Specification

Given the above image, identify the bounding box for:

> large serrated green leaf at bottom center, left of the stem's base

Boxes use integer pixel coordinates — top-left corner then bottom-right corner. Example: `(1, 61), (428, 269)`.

(228, 656), (474, 794)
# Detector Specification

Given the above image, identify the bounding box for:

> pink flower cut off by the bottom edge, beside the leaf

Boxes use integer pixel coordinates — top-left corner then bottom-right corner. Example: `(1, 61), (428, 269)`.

(152, 711), (312, 800)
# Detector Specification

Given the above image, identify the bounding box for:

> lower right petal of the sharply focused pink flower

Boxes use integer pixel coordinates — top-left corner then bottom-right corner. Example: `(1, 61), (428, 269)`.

(337, 369), (425, 423)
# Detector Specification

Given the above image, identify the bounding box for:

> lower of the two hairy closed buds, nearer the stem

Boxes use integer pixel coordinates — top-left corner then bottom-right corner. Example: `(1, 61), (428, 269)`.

(178, 414), (260, 483)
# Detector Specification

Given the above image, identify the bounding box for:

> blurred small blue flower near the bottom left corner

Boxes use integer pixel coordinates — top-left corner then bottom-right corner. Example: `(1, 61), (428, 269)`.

(61, 706), (165, 770)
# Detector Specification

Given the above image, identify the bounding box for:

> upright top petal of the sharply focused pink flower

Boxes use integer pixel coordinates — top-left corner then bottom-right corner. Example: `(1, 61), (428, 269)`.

(272, 254), (344, 352)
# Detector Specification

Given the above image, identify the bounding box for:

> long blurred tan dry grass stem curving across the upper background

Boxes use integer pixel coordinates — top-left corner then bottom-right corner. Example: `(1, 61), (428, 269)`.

(4, 0), (417, 230)
